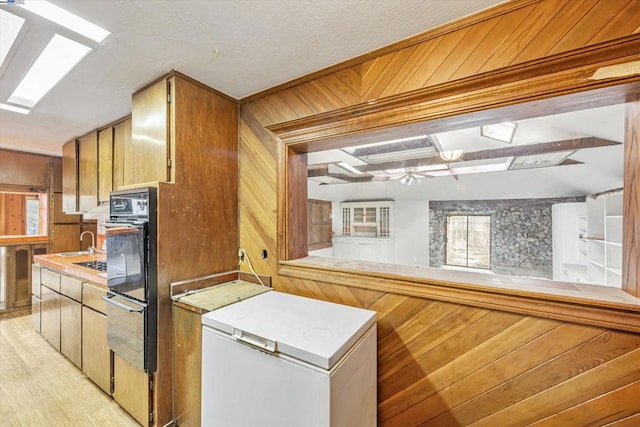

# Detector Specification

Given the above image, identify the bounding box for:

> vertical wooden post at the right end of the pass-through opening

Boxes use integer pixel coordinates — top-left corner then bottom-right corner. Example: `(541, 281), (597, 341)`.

(622, 96), (640, 297)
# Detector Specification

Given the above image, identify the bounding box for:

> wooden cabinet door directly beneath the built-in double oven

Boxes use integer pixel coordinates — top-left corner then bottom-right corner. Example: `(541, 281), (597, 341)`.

(113, 353), (150, 426)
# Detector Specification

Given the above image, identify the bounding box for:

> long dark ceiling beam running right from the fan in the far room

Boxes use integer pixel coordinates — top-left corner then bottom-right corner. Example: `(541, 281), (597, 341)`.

(355, 137), (620, 172)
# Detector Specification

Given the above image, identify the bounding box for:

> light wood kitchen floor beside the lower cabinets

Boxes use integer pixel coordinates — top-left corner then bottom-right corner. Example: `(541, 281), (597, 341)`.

(0, 311), (139, 427)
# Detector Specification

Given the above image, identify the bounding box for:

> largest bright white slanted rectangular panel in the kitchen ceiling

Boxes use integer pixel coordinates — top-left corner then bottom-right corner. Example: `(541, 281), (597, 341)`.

(9, 34), (91, 108)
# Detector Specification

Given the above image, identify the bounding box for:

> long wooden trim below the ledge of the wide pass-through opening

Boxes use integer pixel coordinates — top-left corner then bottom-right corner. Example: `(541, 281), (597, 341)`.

(278, 260), (640, 333)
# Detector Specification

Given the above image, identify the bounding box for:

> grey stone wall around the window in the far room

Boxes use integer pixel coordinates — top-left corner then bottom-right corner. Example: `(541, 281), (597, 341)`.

(429, 197), (585, 279)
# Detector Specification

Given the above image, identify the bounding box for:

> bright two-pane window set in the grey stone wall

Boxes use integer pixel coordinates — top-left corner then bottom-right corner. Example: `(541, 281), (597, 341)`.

(446, 215), (491, 269)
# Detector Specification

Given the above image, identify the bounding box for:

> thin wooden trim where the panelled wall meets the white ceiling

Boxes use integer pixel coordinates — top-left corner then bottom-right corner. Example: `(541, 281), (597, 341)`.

(239, 0), (541, 105)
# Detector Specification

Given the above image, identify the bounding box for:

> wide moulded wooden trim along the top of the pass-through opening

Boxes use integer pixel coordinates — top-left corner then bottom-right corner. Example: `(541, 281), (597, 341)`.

(267, 34), (640, 144)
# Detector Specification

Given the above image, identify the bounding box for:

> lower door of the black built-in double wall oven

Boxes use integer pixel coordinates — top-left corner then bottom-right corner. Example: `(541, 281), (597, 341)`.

(102, 292), (149, 372)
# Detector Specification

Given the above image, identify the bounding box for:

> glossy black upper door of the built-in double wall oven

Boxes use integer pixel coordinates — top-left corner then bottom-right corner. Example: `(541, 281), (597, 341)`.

(105, 223), (149, 302)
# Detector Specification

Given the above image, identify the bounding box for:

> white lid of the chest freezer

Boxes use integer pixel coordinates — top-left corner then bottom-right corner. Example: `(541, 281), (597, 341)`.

(202, 291), (376, 369)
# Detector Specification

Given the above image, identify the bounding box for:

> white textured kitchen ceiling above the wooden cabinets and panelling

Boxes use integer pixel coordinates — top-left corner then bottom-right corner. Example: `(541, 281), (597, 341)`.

(0, 0), (503, 155)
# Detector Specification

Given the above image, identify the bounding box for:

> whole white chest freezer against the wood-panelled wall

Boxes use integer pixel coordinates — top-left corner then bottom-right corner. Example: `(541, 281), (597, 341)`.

(201, 291), (377, 427)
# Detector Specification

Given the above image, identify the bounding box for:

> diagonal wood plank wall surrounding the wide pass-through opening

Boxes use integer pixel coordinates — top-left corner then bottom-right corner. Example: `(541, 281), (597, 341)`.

(239, 0), (640, 426)
